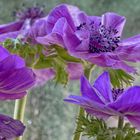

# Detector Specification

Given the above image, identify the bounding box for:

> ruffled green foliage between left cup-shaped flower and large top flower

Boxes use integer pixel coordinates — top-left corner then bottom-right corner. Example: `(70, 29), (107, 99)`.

(3, 39), (81, 85)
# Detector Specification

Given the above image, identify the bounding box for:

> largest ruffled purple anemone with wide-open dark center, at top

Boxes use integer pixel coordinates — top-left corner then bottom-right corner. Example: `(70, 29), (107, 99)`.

(37, 4), (140, 73)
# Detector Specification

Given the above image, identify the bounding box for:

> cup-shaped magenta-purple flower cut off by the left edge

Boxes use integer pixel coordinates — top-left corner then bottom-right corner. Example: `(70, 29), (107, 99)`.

(0, 46), (35, 100)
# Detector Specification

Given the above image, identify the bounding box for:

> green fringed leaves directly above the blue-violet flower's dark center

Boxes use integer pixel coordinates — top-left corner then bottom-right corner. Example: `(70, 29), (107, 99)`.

(109, 69), (134, 88)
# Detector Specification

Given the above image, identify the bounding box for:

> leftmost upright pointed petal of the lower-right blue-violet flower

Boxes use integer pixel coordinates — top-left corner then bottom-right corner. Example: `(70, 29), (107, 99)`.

(81, 77), (103, 104)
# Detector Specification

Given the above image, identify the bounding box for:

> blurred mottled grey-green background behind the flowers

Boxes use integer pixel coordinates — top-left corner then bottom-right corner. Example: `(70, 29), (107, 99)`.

(0, 0), (140, 140)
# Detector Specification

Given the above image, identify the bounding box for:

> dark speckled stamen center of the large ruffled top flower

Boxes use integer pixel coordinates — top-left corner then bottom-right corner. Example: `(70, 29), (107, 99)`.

(77, 22), (120, 53)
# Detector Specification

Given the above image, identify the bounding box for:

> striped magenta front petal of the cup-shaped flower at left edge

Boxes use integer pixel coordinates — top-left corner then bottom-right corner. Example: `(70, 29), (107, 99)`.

(0, 68), (35, 96)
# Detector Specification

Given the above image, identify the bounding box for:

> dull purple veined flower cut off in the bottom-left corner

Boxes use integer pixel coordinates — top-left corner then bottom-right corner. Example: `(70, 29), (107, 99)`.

(0, 114), (25, 140)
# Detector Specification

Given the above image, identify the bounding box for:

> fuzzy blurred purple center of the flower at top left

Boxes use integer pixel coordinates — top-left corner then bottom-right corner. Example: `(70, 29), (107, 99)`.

(16, 7), (44, 20)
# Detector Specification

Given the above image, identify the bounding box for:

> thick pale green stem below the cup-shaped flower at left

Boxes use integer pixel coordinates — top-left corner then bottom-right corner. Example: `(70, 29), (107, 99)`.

(14, 95), (27, 140)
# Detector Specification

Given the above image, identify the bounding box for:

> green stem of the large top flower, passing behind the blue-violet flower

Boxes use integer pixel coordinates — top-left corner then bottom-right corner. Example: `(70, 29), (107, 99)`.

(73, 66), (93, 140)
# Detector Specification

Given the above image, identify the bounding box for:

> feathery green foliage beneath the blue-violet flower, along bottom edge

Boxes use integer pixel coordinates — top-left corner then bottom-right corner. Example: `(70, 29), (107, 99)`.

(76, 115), (140, 140)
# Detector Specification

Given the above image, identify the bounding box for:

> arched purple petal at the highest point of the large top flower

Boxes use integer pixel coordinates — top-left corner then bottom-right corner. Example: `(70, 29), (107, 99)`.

(47, 4), (75, 33)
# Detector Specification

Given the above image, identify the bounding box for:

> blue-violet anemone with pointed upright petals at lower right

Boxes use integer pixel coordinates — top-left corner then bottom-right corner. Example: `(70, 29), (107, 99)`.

(65, 72), (140, 130)
